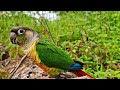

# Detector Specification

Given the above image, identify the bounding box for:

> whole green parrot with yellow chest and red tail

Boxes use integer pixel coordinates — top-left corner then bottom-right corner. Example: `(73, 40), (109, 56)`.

(10, 26), (94, 78)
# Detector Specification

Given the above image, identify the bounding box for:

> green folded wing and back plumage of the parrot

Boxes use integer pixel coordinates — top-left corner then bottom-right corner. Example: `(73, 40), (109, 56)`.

(36, 40), (74, 70)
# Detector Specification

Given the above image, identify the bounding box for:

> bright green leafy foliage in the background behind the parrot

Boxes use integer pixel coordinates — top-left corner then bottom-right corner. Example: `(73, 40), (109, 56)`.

(0, 11), (120, 79)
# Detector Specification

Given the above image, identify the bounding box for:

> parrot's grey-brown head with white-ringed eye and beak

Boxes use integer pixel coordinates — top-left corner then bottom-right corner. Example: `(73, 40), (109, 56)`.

(10, 26), (40, 49)
